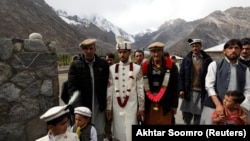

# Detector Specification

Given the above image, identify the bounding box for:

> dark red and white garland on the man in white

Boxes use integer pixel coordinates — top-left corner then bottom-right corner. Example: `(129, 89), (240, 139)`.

(115, 62), (134, 107)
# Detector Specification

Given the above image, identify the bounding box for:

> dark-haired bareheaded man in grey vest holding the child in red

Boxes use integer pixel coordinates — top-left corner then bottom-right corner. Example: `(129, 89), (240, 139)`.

(200, 39), (250, 125)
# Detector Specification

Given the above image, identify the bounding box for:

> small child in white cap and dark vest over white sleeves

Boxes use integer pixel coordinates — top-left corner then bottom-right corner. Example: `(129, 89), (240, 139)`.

(71, 107), (97, 141)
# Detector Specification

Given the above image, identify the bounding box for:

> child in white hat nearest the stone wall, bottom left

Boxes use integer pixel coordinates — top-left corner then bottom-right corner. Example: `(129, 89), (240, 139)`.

(36, 106), (79, 141)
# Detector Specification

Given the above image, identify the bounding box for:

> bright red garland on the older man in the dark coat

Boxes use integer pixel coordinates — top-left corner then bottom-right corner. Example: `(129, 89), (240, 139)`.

(142, 57), (172, 102)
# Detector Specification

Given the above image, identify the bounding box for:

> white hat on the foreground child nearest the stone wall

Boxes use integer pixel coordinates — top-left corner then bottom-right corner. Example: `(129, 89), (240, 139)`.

(40, 105), (69, 122)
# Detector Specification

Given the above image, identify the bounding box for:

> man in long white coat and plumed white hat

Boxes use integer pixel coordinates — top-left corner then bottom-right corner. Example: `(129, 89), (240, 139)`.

(106, 36), (144, 141)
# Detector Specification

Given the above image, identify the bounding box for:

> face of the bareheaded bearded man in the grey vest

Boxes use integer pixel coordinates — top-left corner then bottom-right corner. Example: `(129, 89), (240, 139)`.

(223, 44), (241, 61)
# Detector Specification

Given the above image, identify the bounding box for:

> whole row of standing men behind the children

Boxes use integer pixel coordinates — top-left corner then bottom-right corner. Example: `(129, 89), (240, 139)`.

(63, 36), (250, 141)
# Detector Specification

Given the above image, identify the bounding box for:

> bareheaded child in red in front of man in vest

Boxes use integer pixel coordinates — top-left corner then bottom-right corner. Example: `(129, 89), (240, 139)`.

(212, 90), (248, 125)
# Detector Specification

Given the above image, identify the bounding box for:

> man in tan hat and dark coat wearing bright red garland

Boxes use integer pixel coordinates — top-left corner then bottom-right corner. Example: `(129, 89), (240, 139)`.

(142, 42), (178, 125)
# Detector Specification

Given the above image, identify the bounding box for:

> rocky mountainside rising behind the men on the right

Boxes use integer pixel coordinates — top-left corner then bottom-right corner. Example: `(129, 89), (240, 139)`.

(135, 7), (250, 56)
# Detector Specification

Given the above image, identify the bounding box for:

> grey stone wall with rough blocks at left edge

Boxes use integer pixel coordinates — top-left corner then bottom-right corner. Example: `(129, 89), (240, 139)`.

(0, 38), (59, 141)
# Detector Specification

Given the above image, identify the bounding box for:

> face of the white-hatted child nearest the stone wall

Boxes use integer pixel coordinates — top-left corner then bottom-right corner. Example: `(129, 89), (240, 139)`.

(49, 117), (68, 136)
